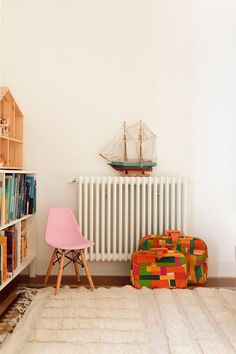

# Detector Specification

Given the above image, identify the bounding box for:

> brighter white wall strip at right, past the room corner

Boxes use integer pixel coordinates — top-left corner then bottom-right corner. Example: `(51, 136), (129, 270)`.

(192, 0), (236, 276)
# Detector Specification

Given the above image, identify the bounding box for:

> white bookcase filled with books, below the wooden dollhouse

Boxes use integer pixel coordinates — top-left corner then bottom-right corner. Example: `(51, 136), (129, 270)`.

(0, 170), (37, 291)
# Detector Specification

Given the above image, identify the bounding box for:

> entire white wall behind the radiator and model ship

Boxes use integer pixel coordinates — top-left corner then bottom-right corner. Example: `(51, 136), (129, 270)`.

(2, 0), (236, 276)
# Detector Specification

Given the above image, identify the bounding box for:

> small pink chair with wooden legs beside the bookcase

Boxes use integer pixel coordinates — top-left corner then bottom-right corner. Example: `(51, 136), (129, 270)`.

(44, 208), (94, 295)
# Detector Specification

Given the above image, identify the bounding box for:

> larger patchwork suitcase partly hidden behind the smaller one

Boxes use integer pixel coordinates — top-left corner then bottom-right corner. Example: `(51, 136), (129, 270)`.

(139, 235), (208, 284)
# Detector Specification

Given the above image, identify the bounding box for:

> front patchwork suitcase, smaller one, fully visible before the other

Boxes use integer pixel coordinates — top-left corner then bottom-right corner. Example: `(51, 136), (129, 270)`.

(130, 248), (187, 289)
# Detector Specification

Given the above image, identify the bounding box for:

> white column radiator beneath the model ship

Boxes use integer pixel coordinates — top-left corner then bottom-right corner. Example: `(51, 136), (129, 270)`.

(70, 177), (187, 261)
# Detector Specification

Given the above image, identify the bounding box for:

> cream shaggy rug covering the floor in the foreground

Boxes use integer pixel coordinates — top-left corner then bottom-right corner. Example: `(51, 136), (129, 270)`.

(1, 286), (236, 354)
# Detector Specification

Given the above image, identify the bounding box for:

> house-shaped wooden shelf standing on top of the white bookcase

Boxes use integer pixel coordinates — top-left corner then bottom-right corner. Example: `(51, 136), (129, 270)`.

(0, 87), (23, 170)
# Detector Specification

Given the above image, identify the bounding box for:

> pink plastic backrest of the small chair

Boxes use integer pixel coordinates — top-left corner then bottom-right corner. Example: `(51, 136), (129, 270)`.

(46, 208), (84, 247)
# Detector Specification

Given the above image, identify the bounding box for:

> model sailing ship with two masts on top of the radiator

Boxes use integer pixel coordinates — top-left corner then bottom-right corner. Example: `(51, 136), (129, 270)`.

(99, 121), (157, 176)
